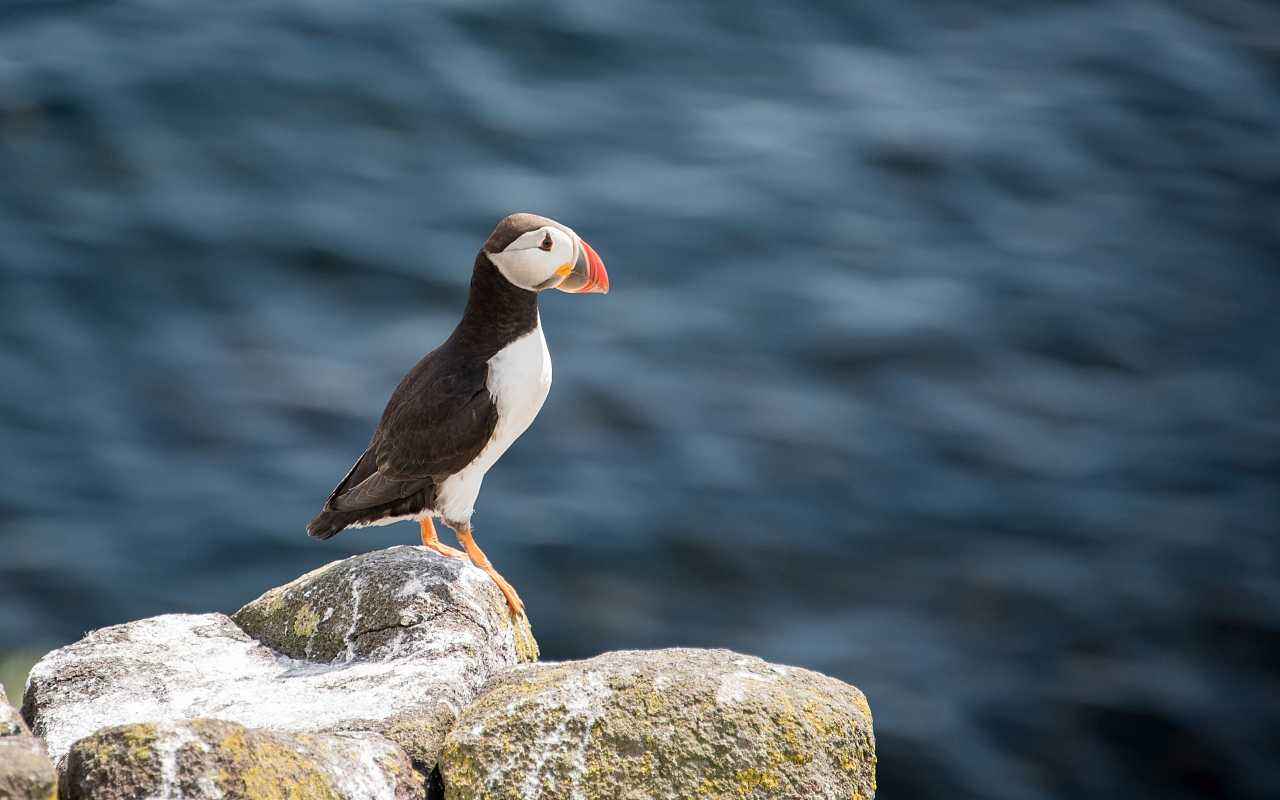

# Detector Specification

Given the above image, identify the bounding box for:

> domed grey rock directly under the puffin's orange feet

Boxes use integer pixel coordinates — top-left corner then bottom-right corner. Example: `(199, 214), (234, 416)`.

(232, 545), (538, 660)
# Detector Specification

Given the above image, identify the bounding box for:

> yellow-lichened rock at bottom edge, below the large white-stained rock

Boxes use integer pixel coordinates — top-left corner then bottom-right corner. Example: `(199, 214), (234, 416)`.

(61, 719), (426, 800)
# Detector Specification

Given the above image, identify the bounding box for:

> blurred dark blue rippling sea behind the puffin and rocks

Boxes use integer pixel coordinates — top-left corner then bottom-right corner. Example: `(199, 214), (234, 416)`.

(0, 0), (1280, 799)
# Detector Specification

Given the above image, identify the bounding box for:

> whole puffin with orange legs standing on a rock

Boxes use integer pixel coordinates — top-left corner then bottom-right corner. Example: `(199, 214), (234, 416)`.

(307, 212), (609, 617)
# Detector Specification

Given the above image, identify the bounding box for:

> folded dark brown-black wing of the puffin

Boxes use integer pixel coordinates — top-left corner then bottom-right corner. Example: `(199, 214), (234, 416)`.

(325, 353), (498, 511)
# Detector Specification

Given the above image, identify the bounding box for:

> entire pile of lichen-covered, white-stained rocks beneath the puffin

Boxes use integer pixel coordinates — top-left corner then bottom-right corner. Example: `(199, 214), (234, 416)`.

(15, 547), (876, 800)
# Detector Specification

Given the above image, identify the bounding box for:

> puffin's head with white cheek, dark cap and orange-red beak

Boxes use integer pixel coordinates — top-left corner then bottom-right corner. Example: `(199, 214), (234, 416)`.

(484, 214), (609, 294)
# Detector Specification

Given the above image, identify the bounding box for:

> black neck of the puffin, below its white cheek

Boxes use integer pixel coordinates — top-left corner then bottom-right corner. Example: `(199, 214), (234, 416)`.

(451, 250), (538, 360)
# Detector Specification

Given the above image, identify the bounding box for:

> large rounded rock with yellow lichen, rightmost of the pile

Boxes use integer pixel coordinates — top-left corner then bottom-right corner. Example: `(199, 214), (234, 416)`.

(442, 649), (876, 800)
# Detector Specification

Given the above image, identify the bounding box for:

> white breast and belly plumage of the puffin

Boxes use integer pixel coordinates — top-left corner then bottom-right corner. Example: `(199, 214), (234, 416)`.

(435, 319), (552, 522)
